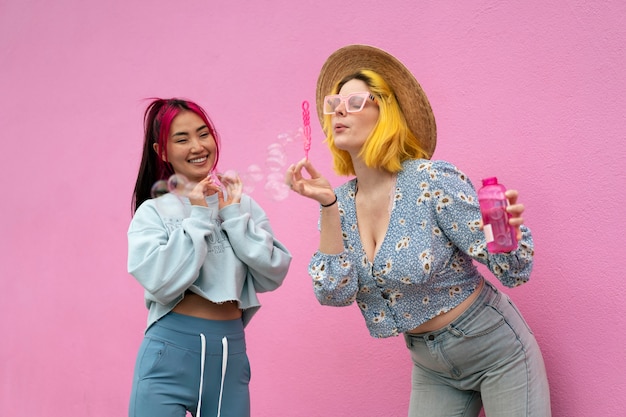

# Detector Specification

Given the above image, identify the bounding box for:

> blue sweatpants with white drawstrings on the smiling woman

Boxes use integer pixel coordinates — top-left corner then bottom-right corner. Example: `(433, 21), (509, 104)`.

(128, 313), (250, 417)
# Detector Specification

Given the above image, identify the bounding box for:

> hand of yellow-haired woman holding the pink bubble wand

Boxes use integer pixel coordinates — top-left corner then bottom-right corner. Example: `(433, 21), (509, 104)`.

(285, 158), (335, 205)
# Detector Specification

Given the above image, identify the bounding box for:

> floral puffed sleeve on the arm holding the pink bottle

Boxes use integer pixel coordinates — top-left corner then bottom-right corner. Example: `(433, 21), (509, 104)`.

(427, 161), (534, 287)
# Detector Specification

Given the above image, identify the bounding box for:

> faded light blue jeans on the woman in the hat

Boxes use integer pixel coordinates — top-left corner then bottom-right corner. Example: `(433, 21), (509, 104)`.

(404, 281), (551, 417)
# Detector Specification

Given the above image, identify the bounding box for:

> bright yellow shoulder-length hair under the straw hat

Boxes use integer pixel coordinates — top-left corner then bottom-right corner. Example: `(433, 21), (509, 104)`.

(323, 70), (428, 175)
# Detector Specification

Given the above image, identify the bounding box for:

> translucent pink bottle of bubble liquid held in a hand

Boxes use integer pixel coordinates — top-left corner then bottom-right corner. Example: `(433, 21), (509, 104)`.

(478, 177), (517, 253)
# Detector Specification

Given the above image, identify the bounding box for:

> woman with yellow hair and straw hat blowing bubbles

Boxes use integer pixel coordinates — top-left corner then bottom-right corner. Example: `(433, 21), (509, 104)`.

(285, 45), (550, 417)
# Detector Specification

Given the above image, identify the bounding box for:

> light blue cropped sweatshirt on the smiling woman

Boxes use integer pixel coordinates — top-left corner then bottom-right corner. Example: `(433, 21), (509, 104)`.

(128, 193), (291, 327)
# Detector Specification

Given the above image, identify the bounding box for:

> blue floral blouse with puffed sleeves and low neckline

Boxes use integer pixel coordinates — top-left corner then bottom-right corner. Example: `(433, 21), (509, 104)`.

(309, 160), (533, 337)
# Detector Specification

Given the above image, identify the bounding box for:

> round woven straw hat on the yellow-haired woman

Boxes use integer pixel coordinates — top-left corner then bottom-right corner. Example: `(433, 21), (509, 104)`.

(316, 45), (437, 157)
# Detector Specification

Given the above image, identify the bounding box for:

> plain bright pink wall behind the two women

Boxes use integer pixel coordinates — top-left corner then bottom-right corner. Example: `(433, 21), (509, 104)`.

(0, 0), (626, 417)
